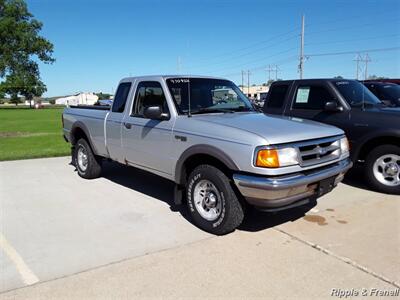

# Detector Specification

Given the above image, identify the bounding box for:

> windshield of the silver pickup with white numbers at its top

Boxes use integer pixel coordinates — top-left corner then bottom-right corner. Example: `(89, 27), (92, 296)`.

(167, 78), (253, 114)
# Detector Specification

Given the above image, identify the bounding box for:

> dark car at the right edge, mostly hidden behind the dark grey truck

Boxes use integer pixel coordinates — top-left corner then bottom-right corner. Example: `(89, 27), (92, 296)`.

(363, 81), (400, 107)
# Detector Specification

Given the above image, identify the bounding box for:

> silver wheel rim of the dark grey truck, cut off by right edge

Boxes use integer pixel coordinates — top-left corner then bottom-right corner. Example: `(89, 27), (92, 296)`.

(373, 154), (400, 186)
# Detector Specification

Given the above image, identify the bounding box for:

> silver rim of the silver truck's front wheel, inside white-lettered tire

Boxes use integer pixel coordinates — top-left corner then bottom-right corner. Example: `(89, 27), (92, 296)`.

(193, 179), (222, 221)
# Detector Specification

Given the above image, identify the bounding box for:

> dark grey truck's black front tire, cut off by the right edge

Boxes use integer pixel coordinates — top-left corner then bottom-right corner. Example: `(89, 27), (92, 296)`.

(365, 145), (400, 195)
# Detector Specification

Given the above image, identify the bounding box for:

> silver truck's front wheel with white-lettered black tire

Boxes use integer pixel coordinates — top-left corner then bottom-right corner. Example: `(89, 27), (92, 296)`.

(186, 165), (244, 235)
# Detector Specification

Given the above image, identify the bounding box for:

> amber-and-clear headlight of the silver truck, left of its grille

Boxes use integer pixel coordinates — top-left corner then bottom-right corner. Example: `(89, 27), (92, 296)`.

(255, 148), (299, 168)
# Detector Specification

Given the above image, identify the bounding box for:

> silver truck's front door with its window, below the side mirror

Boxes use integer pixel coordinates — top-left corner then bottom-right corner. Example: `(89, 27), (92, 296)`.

(122, 81), (173, 175)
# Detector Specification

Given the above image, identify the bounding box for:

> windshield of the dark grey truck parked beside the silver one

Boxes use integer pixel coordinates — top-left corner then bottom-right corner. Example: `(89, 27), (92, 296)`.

(335, 80), (382, 107)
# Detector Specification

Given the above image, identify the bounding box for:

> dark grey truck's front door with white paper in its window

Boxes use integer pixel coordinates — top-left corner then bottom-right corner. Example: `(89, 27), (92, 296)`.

(285, 81), (350, 129)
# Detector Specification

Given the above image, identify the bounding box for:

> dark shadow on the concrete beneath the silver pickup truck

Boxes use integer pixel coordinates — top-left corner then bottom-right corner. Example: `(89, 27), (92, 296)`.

(102, 161), (316, 232)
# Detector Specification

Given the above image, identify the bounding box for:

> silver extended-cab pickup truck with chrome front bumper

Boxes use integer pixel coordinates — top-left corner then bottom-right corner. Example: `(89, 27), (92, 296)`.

(63, 76), (352, 234)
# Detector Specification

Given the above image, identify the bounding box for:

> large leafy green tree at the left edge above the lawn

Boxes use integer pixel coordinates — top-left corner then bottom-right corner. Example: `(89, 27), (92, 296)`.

(0, 0), (55, 104)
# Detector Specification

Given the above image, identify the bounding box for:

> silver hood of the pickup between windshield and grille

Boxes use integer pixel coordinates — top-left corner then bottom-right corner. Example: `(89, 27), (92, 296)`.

(193, 113), (344, 144)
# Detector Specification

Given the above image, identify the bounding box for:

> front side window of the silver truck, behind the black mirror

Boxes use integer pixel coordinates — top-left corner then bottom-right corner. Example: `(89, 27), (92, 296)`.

(132, 81), (169, 118)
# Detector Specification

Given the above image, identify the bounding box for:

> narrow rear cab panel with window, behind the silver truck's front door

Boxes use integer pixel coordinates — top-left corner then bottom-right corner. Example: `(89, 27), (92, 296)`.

(105, 82), (132, 163)
